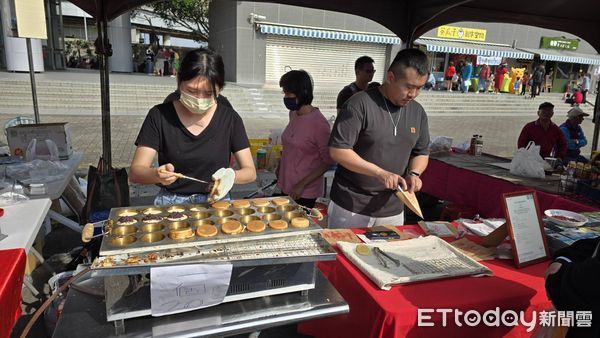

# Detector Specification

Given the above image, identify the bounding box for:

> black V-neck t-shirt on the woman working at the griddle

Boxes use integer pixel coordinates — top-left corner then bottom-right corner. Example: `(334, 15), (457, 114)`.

(135, 103), (250, 194)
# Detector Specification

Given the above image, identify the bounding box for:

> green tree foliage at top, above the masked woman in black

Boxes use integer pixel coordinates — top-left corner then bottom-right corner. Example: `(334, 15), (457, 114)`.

(142, 0), (210, 42)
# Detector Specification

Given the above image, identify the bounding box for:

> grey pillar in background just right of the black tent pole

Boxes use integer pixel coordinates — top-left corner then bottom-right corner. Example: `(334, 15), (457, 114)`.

(108, 12), (133, 73)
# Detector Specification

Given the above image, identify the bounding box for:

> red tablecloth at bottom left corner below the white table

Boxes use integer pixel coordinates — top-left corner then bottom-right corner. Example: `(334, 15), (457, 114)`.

(0, 249), (26, 337)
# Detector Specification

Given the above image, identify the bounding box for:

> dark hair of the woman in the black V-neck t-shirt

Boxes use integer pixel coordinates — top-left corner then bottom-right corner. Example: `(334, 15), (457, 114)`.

(177, 48), (225, 98)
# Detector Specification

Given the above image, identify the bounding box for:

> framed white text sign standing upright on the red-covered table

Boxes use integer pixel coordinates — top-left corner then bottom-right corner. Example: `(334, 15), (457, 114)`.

(506, 194), (546, 262)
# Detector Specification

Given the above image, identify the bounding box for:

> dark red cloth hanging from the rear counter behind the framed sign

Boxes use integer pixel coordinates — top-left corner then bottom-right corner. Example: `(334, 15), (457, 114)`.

(422, 159), (596, 217)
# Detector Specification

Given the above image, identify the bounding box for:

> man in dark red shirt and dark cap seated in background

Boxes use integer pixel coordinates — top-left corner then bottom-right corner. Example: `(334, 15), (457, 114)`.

(517, 102), (567, 159)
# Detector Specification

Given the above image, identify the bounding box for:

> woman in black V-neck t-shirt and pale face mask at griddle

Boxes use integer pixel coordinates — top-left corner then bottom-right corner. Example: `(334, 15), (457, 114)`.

(129, 48), (256, 205)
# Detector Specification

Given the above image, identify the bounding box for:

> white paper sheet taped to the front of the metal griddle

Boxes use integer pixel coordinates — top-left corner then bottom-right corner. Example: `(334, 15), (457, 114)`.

(150, 264), (233, 316)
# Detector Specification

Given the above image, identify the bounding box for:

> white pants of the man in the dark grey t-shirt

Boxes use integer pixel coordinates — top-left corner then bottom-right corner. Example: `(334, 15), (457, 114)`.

(327, 201), (404, 229)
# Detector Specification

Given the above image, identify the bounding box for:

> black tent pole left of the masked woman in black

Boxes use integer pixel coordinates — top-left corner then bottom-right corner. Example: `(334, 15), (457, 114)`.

(95, 0), (112, 168)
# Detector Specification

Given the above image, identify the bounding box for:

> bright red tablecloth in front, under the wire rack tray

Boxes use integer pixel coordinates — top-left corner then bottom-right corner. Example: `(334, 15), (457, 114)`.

(299, 227), (551, 338)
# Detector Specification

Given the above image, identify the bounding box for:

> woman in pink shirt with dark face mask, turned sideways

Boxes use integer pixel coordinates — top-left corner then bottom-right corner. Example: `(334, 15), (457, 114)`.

(277, 70), (334, 208)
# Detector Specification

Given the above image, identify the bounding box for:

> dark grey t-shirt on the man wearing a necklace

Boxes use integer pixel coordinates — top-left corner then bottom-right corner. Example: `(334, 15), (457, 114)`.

(329, 88), (429, 217)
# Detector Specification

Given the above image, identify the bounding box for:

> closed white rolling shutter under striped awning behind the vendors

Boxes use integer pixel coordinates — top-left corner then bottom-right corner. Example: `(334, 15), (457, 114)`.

(265, 35), (387, 85)
